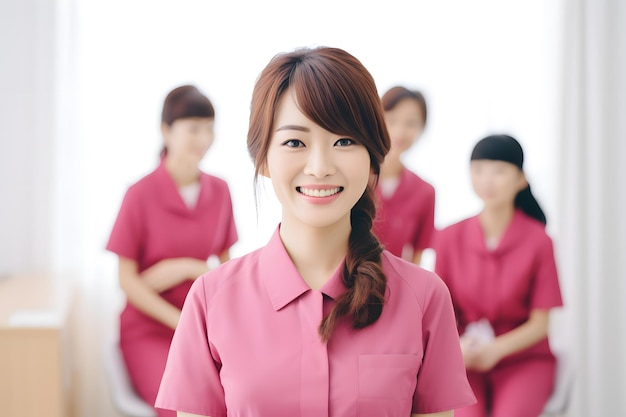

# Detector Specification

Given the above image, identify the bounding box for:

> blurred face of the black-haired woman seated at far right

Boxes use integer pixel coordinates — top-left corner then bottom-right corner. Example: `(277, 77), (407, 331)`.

(470, 159), (527, 207)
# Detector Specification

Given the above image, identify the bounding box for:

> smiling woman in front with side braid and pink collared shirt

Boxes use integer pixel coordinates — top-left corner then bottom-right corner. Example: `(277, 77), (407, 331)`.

(156, 47), (475, 417)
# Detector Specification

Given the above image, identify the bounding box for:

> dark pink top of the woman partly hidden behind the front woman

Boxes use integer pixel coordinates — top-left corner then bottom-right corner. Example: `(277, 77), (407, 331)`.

(374, 167), (435, 260)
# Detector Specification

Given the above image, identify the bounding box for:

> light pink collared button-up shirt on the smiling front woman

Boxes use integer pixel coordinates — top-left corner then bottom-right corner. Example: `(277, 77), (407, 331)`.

(156, 230), (475, 417)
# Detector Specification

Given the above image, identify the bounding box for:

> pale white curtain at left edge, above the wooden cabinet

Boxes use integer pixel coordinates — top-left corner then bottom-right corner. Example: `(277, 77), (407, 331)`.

(0, 0), (56, 276)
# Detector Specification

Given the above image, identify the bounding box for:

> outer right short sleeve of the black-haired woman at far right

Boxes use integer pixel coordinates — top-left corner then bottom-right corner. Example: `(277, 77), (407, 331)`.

(531, 237), (563, 308)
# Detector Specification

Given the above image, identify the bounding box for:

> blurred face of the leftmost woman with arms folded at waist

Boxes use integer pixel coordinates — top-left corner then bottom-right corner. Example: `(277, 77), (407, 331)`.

(162, 117), (214, 165)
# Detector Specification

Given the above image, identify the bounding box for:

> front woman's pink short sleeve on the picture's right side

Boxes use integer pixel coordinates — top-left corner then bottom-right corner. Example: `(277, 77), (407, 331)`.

(413, 276), (476, 414)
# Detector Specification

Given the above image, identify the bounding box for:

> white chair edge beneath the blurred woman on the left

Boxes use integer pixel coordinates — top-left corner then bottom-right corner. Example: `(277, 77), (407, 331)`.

(104, 338), (157, 417)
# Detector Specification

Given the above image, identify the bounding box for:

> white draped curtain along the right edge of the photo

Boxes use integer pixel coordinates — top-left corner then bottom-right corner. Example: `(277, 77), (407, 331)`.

(556, 0), (626, 417)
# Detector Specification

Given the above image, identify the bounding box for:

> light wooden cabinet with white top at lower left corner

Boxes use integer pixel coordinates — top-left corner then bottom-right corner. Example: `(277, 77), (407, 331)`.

(0, 275), (73, 417)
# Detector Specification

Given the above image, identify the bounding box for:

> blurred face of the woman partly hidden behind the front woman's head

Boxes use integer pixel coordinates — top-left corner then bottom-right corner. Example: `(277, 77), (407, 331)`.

(385, 98), (424, 155)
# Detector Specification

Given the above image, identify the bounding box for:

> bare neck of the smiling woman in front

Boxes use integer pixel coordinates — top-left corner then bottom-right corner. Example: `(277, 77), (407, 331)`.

(280, 219), (351, 290)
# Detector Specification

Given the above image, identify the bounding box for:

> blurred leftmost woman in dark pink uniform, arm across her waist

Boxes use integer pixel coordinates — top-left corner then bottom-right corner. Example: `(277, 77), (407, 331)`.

(106, 85), (238, 417)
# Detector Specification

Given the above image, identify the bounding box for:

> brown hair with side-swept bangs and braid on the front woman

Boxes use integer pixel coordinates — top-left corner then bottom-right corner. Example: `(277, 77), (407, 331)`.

(248, 47), (390, 341)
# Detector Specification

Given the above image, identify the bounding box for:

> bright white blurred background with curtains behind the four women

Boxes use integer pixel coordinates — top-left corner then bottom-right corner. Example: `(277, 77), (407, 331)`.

(0, 0), (626, 417)
